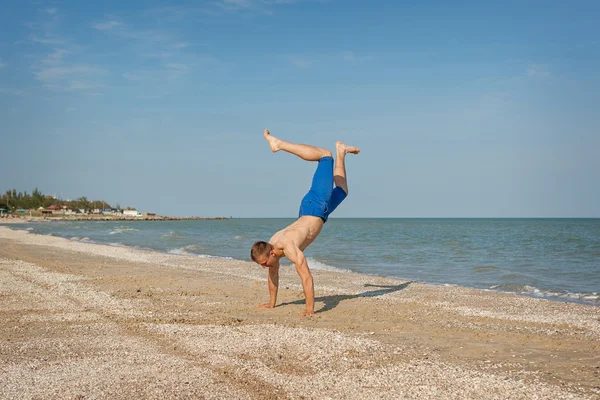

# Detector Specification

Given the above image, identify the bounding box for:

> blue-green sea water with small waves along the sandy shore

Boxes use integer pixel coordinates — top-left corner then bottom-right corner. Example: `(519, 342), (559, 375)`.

(14, 218), (600, 305)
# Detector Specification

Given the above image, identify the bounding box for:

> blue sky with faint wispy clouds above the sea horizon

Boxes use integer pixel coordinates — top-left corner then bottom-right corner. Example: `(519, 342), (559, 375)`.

(0, 0), (600, 217)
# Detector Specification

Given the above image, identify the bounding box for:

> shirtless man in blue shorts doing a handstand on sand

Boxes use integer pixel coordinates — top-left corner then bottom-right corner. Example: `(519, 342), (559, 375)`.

(250, 129), (360, 316)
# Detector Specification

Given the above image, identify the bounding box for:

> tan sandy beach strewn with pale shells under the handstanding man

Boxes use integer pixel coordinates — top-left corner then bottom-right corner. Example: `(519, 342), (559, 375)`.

(0, 226), (600, 399)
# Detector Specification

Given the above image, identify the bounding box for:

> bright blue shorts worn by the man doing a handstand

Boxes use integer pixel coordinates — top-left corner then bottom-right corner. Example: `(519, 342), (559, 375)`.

(298, 156), (347, 222)
